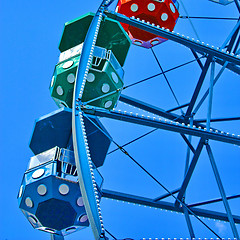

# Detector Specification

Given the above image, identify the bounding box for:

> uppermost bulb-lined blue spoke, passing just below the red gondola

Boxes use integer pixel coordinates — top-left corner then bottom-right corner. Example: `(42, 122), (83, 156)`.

(107, 11), (240, 65)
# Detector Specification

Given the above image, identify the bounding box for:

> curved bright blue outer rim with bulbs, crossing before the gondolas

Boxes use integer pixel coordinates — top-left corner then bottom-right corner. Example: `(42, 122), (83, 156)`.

(72, 0), (109, 239)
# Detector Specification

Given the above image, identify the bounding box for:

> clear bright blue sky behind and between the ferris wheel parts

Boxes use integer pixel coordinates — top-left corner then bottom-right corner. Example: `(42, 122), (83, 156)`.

(0, 0), (240, 240)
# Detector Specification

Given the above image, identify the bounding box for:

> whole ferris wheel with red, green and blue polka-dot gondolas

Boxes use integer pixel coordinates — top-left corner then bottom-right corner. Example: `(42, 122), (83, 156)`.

(18, 0), (240, 240)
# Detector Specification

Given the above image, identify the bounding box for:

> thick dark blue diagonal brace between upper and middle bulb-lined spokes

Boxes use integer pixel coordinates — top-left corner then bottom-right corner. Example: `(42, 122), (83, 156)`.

(185, 56), (212, 117)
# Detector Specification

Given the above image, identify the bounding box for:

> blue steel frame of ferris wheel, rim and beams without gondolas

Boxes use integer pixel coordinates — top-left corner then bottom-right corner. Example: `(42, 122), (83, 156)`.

(69, 0), (240, 239)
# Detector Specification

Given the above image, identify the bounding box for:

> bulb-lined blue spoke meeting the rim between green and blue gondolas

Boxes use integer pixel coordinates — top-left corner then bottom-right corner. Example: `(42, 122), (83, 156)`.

(83, 107), (240, 145)
